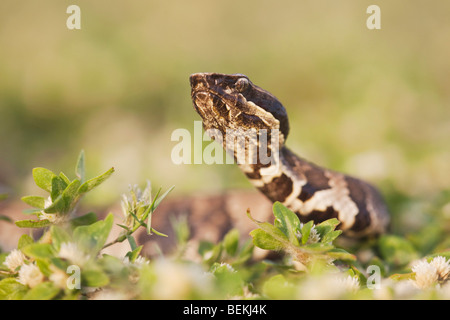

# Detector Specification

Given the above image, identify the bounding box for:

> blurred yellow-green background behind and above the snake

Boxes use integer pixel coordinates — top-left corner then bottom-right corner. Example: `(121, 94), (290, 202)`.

(0, 0), (450, 208)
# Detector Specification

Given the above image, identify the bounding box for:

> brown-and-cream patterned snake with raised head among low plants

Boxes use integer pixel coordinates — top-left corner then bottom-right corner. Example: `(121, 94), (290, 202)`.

(189, 73), (390, 238)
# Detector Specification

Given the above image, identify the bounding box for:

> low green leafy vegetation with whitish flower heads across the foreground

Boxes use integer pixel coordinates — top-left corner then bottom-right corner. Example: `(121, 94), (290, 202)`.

(0, 152), (450, 300)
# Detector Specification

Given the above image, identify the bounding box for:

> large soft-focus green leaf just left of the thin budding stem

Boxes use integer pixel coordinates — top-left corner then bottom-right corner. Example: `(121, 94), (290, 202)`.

(73, 213), (114, 253)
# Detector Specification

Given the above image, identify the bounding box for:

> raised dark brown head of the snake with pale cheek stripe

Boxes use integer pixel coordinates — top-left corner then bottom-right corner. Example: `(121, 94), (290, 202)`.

(190, 73), (289, 143)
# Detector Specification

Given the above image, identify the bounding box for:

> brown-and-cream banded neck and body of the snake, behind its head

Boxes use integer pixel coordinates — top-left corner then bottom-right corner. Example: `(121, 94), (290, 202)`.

(239, 146), (388, 236)
